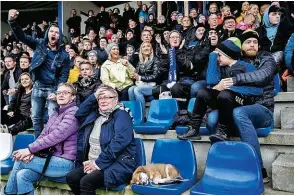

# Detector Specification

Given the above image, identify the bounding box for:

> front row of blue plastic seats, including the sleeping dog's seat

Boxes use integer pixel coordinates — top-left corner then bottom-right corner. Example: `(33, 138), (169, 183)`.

(0, 134), (264, 195)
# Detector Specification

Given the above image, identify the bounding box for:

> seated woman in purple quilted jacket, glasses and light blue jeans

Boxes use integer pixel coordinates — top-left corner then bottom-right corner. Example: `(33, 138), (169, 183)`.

(5, 83), (78, 195)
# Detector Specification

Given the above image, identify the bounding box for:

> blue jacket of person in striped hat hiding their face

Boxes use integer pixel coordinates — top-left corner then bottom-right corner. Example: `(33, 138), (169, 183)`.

(206, 52), (263, 96)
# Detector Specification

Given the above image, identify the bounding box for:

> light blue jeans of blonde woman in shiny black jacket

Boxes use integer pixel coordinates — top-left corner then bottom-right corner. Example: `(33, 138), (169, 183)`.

(128, 85), (154, 115)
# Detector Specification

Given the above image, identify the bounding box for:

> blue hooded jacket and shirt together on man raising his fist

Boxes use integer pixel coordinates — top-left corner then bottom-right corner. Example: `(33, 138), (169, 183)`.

(8, 21), (70, 88)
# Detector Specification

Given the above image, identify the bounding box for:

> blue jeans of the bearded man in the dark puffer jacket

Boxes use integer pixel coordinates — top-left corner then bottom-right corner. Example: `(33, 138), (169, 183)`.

(233, 104), (274, 168)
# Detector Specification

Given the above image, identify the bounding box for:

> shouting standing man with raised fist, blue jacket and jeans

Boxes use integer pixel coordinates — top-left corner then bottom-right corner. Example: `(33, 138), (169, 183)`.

(8, 9), (70, 138)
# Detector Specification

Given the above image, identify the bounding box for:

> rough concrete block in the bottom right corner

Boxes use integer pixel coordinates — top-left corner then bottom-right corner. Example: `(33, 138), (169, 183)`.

(272, 154), (294, 193)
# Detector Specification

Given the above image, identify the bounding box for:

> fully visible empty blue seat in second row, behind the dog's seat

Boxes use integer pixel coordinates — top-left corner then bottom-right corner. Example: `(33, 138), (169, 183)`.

(134, 99), (178, 134)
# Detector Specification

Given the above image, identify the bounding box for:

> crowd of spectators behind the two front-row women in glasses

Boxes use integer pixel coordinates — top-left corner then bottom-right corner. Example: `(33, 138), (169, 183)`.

(1, 1), (294, 193)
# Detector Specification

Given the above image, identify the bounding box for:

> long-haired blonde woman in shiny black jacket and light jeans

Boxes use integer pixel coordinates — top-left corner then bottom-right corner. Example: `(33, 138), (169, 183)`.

(128, 42), (163, 113)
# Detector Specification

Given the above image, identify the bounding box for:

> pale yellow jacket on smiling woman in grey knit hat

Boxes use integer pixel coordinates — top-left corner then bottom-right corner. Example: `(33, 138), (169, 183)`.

(100, 59), (135, 91)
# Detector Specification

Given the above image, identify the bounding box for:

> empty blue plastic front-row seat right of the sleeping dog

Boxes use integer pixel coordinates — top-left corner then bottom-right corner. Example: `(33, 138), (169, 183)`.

(191, 142), (264, 195)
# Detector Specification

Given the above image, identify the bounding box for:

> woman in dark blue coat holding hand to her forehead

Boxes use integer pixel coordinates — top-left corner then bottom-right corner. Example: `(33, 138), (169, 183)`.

(66, 84), (136, 195)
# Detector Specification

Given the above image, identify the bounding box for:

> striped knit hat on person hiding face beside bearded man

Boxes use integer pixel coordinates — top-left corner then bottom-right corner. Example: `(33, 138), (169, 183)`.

(217, 37), (241, 60)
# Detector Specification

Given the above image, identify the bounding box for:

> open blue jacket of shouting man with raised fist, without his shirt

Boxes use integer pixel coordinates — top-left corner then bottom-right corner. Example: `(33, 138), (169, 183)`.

(8, 21), (70, 86)
